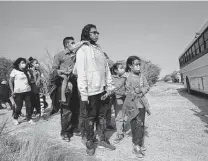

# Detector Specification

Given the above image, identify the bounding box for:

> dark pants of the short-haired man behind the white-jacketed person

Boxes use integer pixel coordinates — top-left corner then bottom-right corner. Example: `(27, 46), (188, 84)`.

(58, 79), (80, 136)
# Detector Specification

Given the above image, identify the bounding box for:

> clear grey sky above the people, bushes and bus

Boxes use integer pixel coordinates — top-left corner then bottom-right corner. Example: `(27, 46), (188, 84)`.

(0, 1), (208, 77)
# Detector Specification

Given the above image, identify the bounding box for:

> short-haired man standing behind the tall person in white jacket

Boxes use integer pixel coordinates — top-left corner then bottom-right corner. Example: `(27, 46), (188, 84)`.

(49, 37), (88, 141)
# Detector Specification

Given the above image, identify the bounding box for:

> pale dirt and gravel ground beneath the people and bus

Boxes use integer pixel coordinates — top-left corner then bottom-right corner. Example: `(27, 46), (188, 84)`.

(0, 82), (208, 161)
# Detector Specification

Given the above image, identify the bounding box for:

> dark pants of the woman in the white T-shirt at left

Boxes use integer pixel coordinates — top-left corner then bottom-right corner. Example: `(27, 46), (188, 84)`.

(14, 92), (32, 121)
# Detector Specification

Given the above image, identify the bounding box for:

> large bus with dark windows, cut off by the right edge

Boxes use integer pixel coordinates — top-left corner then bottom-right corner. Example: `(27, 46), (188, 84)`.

(179, 21), (208, 94)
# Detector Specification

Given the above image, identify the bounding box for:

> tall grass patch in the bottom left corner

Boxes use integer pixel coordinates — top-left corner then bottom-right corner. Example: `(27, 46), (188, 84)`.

(0, 121), (75, 161)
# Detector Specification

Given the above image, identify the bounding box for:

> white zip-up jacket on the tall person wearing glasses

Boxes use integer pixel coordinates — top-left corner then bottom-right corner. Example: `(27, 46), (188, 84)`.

(74, 45), (115, 101)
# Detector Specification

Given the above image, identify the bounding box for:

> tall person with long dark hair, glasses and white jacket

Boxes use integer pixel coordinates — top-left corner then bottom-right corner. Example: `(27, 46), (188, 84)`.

(76, 24), (115, 155)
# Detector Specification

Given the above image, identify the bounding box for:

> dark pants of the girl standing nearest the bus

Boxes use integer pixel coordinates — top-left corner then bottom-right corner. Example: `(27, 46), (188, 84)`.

(130, 108), (145, 146)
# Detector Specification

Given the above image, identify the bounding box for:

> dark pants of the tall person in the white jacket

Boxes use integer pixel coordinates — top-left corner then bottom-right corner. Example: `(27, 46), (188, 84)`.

(86, 93), (106, 148)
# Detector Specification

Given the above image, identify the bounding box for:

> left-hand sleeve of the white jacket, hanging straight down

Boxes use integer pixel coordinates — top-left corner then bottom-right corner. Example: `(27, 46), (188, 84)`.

(76, 48), (88, 101)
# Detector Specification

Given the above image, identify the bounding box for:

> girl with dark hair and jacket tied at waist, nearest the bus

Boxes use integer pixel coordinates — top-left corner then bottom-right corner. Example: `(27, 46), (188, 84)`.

(123, 56), (151, 158)
